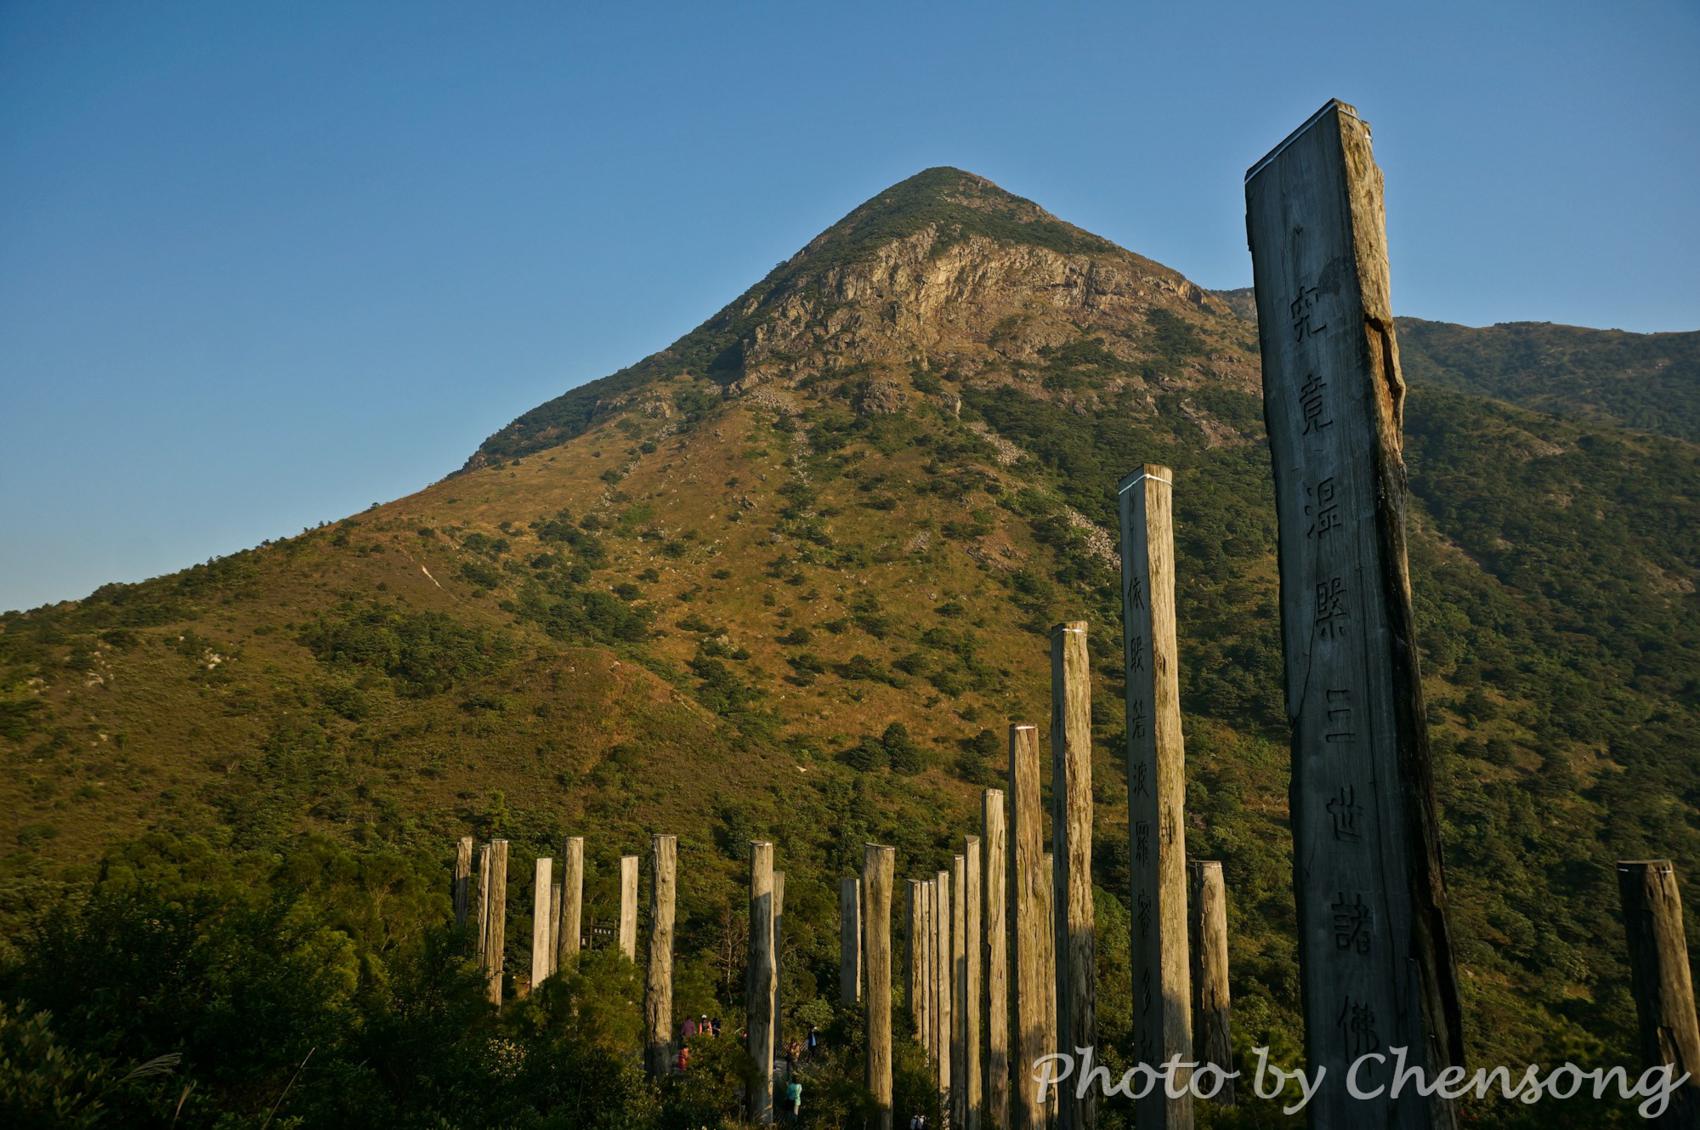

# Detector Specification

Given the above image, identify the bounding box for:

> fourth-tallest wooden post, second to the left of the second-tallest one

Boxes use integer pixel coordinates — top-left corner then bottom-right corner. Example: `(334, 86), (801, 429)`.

(1010, 726), (1054, 1130)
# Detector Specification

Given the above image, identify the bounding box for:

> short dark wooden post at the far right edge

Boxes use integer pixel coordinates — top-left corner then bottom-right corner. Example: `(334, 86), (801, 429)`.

(1617, 860), (1700, 1130)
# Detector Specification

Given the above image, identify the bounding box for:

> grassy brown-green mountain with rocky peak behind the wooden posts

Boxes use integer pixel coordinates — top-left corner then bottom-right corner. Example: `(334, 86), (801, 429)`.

(0, 170), (1700, 1125)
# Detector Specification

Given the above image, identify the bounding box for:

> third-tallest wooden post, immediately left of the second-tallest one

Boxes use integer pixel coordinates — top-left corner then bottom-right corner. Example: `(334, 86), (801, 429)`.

(1051, 620), (1094, 1130)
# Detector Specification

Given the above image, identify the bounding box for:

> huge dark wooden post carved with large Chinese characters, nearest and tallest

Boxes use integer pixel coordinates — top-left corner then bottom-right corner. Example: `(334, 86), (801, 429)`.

(1246, 102), (1464, 1130)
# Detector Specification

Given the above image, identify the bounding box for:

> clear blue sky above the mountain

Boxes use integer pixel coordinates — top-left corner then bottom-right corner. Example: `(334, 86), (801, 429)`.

(0, 0), (1700, 608)
